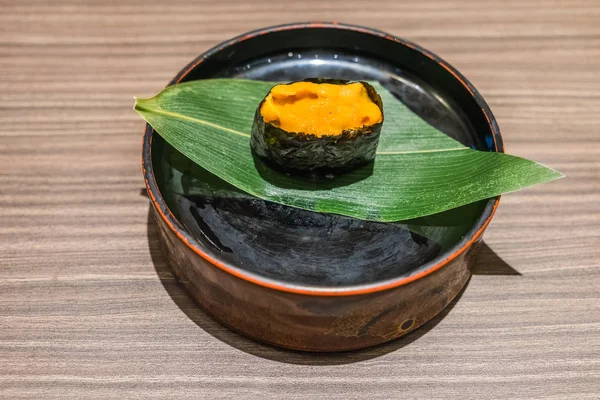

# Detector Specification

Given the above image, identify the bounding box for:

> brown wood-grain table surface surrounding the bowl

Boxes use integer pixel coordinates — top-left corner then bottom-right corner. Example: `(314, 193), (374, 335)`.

(0, 0), (600, 399)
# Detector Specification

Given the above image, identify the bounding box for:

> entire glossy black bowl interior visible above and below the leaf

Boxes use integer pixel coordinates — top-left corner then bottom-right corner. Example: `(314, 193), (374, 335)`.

(152, 28), (496, 287)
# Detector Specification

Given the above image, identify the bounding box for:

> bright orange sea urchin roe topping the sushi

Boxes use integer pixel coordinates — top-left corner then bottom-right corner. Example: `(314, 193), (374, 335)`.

(260, 82), (383, 137)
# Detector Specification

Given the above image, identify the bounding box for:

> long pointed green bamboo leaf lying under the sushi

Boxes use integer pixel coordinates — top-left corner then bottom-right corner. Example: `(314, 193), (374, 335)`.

(134, 79), (562, 222)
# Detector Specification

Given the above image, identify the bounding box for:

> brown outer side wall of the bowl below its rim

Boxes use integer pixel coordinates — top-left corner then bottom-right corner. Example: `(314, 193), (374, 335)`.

(155, 208), (478, 352)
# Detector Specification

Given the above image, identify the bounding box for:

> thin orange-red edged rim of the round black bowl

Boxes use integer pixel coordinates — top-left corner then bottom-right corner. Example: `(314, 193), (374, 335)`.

(142, 22), (504, 296)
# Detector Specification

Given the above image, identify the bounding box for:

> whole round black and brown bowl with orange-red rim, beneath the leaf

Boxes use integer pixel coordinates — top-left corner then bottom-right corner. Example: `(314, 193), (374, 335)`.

(143, 23), (503, 351)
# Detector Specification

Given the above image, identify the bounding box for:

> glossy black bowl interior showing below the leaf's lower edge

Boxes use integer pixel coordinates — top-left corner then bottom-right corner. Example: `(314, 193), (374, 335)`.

(159, 151), (486, 287)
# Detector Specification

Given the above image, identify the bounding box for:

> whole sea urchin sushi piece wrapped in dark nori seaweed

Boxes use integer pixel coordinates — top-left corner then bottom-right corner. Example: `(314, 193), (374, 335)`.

(250, 79), (383, 174)
